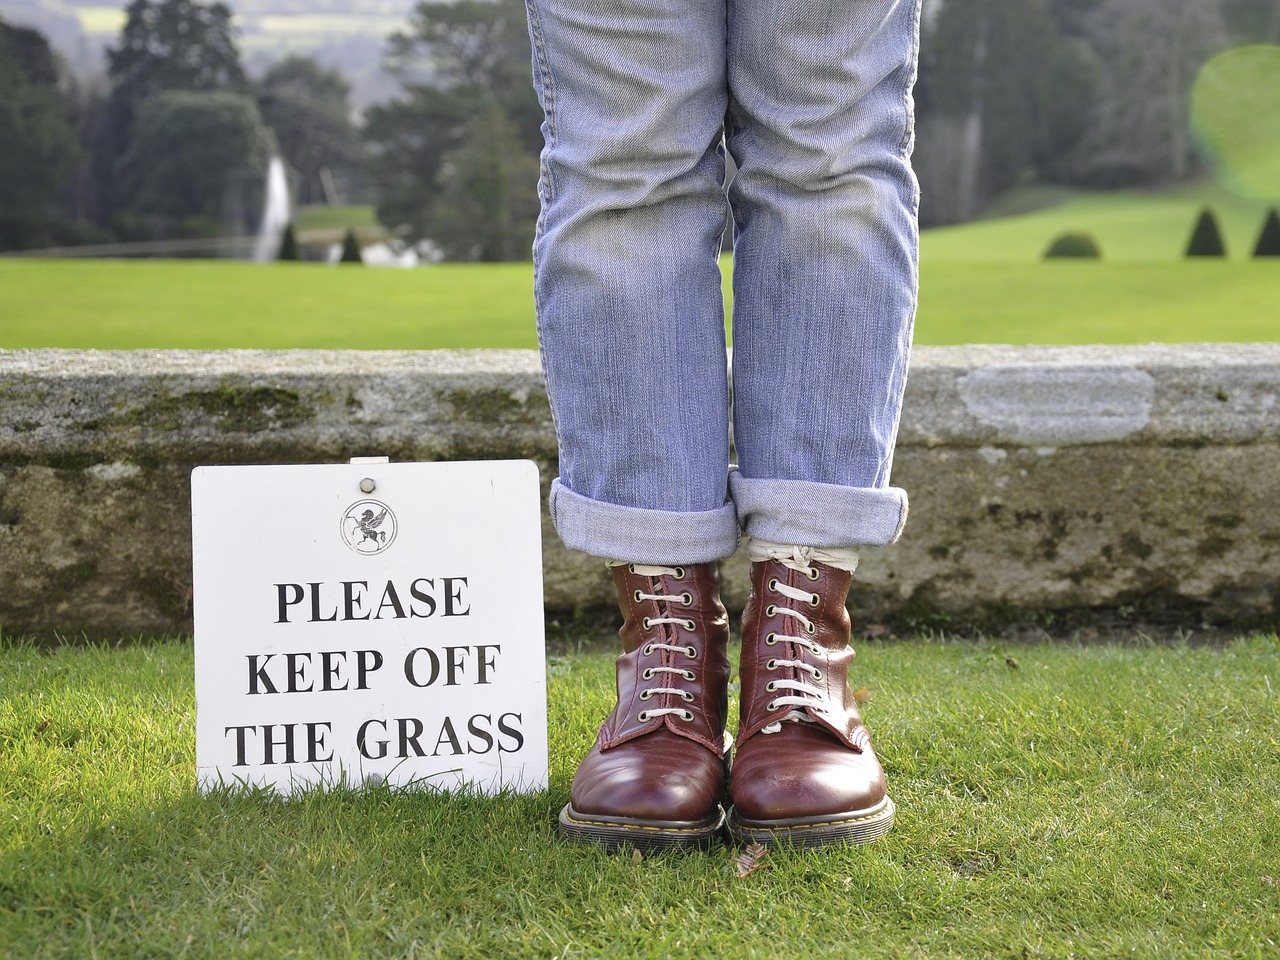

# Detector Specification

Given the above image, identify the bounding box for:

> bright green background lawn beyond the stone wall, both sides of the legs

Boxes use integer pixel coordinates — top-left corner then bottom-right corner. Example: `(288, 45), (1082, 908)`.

(0, 187), (1280, 349)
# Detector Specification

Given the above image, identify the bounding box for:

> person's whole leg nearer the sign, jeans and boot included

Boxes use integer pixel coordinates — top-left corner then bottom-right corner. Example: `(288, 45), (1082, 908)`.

(529, 0), (737, 847)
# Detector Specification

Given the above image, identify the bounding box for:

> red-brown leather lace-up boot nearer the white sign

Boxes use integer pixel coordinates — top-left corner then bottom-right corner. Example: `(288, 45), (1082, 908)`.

(559, 563), (728, 849)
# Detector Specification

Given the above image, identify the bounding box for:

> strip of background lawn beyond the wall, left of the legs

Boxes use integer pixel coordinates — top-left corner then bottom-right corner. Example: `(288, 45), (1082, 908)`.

(0, 260), (536, 349)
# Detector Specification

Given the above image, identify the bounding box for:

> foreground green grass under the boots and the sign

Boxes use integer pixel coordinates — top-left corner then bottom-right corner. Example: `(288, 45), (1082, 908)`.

(0, 636), (1280, 959)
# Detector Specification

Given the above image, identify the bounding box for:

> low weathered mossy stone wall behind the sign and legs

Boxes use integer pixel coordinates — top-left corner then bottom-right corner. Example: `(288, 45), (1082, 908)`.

(0, 344), (1280, 636)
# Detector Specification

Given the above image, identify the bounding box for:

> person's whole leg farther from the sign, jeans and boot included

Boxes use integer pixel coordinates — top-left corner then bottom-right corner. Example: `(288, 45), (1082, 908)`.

(726, 0), (919, 846)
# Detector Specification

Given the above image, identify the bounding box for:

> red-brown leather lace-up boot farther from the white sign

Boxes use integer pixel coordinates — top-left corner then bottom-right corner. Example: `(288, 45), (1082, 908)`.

(728, 559), (893, 847)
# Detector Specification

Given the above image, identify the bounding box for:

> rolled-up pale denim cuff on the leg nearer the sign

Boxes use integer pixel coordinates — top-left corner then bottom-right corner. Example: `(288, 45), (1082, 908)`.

(550, 479), (739, 566)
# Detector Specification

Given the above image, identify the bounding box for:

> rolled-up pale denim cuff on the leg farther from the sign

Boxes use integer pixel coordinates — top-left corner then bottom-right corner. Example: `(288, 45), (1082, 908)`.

(728, 470), (906, 548)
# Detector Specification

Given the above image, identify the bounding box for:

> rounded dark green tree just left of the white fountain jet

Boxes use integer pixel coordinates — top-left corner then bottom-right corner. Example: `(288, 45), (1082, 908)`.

(118, 91), (273, 233)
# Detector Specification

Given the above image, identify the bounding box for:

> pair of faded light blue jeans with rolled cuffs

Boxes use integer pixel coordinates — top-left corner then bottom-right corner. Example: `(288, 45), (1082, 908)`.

(526, 0), (919, 563)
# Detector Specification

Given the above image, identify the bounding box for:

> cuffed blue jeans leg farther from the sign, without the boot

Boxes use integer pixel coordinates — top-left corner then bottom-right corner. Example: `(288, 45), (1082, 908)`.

(726, 0), (919, 547)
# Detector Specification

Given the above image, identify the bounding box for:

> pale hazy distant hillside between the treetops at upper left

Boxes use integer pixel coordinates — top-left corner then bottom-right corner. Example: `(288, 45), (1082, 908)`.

(0, 0), (415, 108)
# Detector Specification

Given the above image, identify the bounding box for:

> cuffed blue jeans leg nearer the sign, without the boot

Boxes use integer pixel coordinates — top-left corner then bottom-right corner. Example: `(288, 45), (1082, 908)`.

(529, 0), (737, 563)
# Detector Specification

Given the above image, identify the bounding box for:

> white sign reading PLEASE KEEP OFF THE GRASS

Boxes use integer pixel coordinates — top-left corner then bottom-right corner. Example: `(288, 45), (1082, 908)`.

(191, 461), (547, 794)
